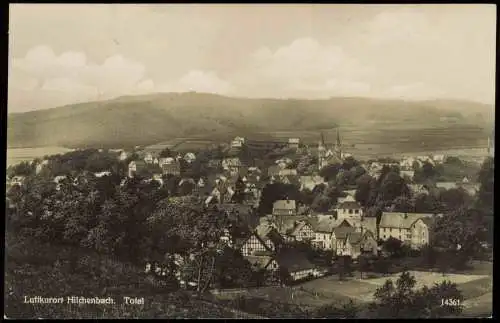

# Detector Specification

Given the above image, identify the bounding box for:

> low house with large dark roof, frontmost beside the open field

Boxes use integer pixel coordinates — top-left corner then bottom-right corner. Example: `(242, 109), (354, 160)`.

(275, 249), (317, 284)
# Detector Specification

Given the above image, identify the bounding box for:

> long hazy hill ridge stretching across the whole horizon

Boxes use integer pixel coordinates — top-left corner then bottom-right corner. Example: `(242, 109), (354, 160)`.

(8, 93), (493, 147)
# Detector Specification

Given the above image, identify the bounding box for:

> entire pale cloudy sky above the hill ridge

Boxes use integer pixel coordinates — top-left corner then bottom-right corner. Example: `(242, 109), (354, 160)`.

(8, 4), (496, 112)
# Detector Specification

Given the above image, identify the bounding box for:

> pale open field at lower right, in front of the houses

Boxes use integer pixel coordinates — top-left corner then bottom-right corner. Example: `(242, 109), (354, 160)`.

(217, 262), (493, 317)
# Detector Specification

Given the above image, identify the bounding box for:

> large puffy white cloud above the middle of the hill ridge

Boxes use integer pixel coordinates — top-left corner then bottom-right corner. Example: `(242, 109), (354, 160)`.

(234, 38), (372, 96)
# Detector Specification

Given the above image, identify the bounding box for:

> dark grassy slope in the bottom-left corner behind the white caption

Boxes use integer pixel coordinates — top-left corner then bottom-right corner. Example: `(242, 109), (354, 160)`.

(4, 238), (247, 319)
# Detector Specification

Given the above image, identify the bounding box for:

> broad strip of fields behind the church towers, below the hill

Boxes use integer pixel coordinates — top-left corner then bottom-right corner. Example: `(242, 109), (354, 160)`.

(143, 124), (488, 161)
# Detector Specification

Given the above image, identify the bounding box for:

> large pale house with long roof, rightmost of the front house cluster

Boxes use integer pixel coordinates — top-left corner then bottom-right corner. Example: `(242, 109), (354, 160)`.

(379, 212), (434, 249)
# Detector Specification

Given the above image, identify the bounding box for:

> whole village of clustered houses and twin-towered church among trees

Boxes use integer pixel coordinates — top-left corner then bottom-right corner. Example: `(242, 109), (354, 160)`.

(8, 131), (492, 290)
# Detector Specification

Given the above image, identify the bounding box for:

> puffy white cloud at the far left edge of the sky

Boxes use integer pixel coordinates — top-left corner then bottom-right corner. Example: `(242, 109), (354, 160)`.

(9, 45), (145, 104)
